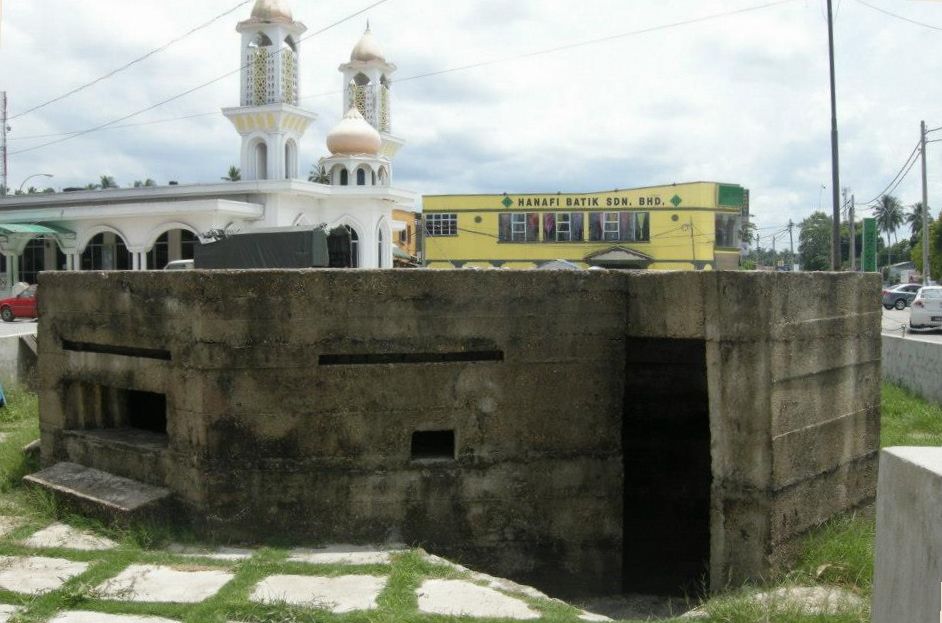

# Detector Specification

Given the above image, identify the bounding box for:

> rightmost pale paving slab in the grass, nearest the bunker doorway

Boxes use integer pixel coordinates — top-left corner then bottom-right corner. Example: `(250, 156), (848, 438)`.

(416, 580), (540, 620)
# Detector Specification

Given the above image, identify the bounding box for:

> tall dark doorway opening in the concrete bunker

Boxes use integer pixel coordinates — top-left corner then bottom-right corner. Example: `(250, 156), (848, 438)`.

(622, 339), (712, 595)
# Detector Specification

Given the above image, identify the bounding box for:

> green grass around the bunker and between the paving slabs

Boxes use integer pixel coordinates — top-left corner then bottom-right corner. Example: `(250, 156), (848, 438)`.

(0, 385), (942, 623)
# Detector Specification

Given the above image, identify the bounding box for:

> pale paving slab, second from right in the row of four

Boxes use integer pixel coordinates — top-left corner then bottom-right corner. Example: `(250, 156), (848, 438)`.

(251, 575), (389, 614)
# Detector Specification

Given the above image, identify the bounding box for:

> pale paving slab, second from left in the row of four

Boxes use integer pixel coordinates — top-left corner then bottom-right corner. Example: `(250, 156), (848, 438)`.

(95, 565), (234, 603)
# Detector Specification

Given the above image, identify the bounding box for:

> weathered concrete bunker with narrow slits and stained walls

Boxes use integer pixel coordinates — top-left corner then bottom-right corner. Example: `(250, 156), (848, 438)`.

(33, 271), (880, 592)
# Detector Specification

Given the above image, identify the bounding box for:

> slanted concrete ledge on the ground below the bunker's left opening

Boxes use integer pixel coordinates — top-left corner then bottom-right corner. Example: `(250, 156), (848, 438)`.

(23, 463), (170, 517)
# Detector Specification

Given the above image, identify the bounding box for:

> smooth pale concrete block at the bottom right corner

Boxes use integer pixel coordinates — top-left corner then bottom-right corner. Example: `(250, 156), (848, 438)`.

(871, 448), (942, 623)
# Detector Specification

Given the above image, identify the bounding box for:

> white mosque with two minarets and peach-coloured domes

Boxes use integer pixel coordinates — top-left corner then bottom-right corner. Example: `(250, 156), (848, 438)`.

(0, 0), (416, 289)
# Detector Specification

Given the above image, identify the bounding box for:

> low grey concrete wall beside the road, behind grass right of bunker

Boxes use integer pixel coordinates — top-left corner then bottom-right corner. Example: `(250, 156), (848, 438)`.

(883, 335), (942, 403)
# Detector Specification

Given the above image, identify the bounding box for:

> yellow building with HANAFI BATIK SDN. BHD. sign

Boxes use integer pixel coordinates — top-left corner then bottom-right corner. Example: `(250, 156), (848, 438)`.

(423, 182), (749, 270)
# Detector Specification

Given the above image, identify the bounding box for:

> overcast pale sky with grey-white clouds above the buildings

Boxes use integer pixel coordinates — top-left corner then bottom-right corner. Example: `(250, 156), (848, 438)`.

(0, 0), (942, 246)
